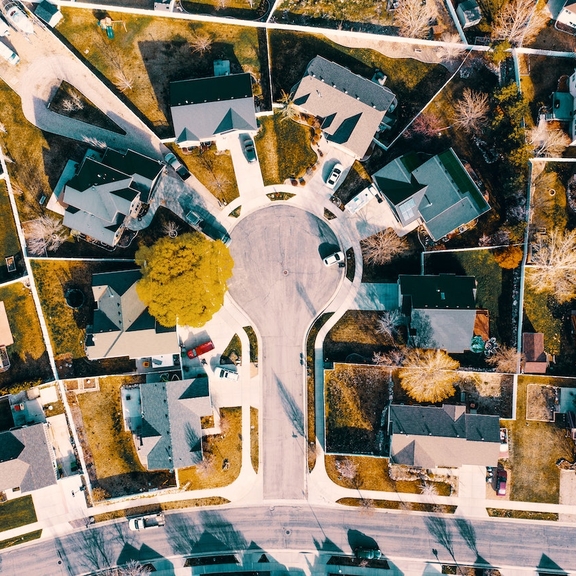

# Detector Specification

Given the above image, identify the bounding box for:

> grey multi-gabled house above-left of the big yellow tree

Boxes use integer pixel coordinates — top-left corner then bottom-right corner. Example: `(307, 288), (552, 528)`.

(56, 148), (163, 246)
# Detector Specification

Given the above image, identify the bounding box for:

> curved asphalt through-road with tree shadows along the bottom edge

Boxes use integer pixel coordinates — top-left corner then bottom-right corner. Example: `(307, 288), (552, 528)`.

(0, 502), (576, 576)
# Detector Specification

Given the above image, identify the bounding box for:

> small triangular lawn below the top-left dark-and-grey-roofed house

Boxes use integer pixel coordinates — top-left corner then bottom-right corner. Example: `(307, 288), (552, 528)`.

(170, 145), (239, 204)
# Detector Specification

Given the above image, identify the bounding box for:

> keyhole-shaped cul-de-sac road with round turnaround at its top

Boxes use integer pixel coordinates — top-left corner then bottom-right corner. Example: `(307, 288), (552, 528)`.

(229, 204), (343, 500)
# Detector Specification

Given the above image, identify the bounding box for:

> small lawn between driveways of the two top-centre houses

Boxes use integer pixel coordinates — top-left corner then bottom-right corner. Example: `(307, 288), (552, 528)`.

(254, 113), (318, 186)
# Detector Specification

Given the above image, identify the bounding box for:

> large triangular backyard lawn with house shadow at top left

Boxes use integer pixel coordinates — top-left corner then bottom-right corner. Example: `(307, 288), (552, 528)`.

(58, 8), (260, 138)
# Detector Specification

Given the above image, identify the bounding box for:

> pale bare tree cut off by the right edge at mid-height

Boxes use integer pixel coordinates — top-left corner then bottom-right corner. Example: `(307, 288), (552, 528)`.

(527, 229), (576, 302)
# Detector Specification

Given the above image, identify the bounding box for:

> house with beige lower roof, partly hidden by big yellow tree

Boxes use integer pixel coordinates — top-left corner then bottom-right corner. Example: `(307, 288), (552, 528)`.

(85, 270), (180, 360)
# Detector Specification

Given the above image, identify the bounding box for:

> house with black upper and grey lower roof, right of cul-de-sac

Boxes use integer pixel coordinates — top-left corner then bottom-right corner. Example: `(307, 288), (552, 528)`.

(398, 274), (487, 354)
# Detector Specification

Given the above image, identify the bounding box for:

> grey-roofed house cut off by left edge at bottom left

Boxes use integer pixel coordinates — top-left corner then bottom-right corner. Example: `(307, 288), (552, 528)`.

(0, 396), (56, 494)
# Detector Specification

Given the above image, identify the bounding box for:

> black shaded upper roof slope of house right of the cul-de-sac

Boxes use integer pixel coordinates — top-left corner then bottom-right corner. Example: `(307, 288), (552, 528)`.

(398, 274), (476, 309)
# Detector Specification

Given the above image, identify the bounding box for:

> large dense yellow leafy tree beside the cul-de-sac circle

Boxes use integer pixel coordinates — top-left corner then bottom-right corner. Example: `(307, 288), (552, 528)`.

(136, 233), (234, 327)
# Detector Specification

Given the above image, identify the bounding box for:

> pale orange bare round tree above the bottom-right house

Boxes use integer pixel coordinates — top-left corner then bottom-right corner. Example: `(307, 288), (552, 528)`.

(398, 348), (460, 402)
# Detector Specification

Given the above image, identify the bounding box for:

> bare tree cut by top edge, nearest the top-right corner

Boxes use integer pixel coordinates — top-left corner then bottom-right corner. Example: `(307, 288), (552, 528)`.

(492, 0), (548, 46)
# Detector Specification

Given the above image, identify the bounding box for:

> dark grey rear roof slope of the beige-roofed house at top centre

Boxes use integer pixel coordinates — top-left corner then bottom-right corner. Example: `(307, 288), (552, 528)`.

(305, 56), (396, 112)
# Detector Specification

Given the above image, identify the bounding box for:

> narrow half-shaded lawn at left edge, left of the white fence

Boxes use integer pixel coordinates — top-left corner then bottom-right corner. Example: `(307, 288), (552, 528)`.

(0, 282), (52, 392)
